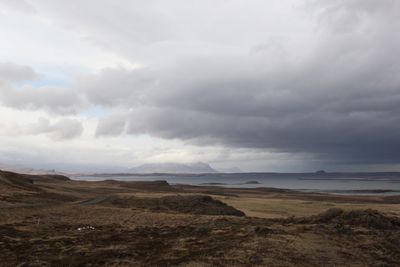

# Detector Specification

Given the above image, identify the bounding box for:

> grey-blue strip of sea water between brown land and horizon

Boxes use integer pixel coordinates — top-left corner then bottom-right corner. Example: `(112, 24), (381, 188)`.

(72, 173), (400, 194)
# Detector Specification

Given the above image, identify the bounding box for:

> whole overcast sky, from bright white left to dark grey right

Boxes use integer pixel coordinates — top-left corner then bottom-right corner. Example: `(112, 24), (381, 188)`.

(0, 0), (400, 172)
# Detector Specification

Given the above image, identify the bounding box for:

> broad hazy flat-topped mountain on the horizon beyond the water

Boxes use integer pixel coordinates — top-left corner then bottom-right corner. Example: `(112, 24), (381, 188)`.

(129, 162), (217, 173)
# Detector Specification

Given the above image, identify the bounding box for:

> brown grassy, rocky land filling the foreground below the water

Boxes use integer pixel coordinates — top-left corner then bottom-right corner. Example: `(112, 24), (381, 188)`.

(0, 172), (400, 266)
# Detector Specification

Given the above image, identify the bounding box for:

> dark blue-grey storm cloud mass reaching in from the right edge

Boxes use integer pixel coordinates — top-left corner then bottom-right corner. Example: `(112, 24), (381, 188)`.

(89, 1), (400, 163)
